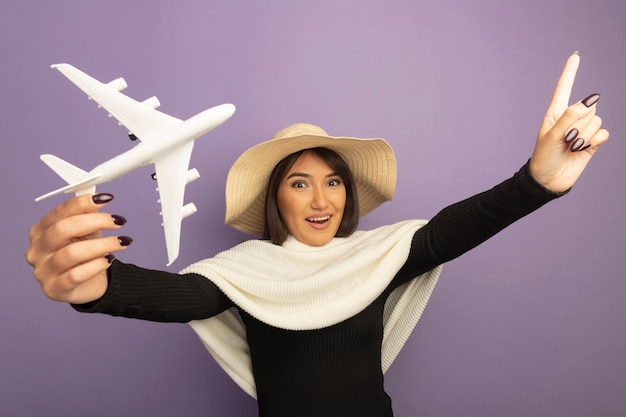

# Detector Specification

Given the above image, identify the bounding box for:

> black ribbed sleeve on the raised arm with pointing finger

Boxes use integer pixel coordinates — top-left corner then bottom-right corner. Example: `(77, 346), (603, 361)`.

(393, 163), (569, 286)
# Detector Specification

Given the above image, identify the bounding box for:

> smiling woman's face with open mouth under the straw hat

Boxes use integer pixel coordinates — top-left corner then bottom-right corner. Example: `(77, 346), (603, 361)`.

(277, 152), (346, 246)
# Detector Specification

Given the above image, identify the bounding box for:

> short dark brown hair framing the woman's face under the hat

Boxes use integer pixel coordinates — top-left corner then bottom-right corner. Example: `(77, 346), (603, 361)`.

(263, 148), (359, 245)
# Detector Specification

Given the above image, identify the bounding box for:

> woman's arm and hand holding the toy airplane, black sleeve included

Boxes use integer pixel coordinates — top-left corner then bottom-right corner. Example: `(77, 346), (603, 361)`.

(26, 194), (232, 322)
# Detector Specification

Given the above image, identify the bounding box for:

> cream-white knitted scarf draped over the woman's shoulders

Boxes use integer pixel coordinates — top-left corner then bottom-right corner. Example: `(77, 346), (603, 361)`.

(181, 220), (442, 398)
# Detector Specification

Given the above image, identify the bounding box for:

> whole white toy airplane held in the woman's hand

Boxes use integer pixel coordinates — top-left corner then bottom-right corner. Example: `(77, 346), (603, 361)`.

(35, 64), (235, 266)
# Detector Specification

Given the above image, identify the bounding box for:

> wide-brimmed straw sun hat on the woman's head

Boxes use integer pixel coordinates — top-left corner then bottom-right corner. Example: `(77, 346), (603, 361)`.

(224, 123), (396, 235)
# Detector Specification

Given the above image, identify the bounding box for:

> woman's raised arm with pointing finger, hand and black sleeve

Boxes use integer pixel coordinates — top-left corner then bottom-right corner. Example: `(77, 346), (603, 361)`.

(397, 53), (609, 282)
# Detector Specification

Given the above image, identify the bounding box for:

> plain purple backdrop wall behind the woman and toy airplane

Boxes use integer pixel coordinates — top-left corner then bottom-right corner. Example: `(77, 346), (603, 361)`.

(0, 0), (626, 417)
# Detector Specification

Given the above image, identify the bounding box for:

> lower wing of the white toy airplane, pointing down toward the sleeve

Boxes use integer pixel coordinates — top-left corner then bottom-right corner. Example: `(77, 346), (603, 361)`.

(154, 141), (195, 266)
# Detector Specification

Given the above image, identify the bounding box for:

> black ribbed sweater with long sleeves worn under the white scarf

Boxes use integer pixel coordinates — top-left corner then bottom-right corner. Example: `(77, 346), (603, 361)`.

(74, 164), (560, 417)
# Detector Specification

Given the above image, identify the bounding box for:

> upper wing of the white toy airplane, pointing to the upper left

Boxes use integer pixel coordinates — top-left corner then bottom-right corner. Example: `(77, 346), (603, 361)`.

(52, 64), (182, 141)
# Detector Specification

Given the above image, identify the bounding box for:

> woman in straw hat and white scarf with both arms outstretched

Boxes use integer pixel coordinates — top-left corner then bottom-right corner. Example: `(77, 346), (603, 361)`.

(26, 54), (609, 417)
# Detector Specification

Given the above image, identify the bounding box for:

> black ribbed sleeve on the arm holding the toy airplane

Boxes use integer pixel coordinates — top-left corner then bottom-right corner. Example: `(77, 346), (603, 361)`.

(72, 260), (233, 323)
